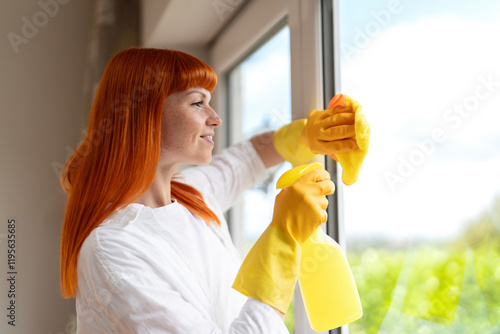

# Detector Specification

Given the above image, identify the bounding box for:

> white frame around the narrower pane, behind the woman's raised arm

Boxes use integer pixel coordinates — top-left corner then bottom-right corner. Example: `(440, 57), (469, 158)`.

(209, 0), (326, 334)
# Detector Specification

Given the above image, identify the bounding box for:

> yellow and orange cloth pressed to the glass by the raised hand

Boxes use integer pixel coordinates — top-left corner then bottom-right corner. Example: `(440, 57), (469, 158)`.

(328, 94), (370, 185)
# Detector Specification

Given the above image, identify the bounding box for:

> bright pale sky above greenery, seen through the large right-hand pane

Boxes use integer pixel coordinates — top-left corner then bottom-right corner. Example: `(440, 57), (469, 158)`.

(339, 1), (500, 239)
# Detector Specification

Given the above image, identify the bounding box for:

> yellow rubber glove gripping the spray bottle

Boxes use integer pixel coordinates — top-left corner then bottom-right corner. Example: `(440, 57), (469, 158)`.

(233, 167), (335, 313)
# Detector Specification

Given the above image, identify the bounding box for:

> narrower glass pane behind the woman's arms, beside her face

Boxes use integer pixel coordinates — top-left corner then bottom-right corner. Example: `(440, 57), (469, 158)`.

(228, 27), (293, 333)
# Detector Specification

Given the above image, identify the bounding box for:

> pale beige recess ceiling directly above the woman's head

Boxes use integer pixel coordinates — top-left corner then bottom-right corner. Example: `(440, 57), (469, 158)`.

(142, 0), (249, 47)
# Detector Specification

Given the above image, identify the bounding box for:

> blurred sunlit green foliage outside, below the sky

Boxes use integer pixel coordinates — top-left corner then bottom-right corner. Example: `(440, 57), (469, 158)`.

(348, 199), (500, 334)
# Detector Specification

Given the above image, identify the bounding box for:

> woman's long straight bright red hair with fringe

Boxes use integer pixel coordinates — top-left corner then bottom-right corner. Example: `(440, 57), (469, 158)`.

(61, 48), (220, 298)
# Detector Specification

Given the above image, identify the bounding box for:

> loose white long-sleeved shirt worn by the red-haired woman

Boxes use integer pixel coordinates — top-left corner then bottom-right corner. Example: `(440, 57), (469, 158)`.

(76, 142), (288, 334)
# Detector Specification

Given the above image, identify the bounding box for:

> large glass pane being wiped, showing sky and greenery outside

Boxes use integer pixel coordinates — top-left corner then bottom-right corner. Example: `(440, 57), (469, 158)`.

(339, 0), (500, 334)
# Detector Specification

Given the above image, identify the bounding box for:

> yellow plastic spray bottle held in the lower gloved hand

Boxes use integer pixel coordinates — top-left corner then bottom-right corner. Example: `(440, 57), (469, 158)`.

(276, 162), (363, 332)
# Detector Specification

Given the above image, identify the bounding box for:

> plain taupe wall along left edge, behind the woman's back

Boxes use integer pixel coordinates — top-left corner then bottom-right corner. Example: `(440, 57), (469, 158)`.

(0, 0), (94, 334)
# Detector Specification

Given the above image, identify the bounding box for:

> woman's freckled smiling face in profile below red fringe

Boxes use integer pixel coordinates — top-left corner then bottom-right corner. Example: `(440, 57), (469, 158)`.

(161, 87), (222, 165)
